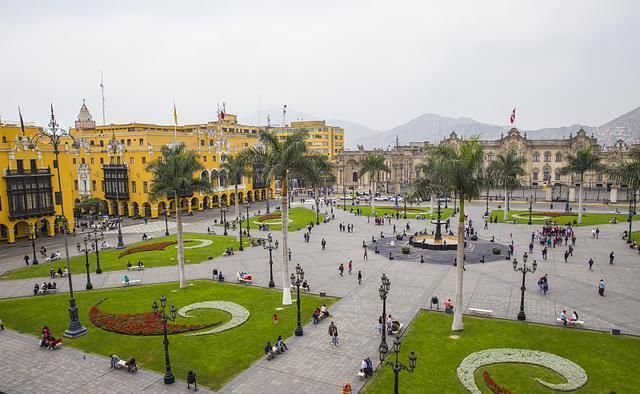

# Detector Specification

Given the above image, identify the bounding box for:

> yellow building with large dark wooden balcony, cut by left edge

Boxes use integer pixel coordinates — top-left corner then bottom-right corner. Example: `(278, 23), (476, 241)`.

(0, 117), (74, 243)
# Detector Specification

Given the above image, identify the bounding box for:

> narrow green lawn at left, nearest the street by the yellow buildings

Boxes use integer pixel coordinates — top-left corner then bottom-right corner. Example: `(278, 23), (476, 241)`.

(1, 233), (250, 279)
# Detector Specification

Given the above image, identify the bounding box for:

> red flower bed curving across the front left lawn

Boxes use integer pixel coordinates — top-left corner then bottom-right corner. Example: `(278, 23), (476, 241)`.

(89, 306), (221, 335)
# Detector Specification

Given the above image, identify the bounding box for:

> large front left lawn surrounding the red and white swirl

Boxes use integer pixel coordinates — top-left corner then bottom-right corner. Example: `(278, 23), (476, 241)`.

(0, 281), (335, 390)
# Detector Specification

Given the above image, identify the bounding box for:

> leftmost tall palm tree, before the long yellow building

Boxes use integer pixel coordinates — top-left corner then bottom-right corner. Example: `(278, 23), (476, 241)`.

(147, 144), (211, 288)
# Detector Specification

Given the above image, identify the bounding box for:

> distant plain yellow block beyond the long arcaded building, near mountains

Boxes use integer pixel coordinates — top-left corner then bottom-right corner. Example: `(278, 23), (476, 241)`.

(268, 120), (344, 161)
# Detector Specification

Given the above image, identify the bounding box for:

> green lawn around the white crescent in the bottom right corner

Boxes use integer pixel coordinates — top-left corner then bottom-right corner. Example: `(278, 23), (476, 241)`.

(366, 311), (640, 394)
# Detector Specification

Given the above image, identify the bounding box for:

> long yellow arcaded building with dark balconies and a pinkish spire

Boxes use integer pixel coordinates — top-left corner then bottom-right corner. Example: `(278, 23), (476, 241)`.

(70, 103), (273, 222)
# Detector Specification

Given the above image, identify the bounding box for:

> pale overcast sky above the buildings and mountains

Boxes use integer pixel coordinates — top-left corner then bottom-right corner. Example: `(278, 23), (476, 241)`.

(0, 0), (640, 130)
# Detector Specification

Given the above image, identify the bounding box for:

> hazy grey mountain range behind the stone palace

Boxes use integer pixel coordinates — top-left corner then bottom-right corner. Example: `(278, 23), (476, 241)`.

(336, 107), (640, 149)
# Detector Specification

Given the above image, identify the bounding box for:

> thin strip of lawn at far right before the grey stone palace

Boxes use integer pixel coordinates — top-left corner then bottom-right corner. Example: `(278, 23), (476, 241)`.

(491, 209), (640, 226)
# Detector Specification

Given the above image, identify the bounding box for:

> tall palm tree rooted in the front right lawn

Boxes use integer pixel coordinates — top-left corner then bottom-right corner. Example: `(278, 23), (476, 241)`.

(427, 138), (483, 331)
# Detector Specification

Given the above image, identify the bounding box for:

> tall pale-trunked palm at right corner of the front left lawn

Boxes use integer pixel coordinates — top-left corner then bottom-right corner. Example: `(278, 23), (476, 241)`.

(240, 132), (313, 305)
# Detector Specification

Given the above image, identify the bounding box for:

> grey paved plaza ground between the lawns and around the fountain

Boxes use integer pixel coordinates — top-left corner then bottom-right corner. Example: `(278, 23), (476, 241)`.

(0, 203), (640, 393)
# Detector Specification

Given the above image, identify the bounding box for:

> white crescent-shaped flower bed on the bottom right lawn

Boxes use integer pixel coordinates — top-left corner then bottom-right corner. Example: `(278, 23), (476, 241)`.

(457, 349), (588, 394)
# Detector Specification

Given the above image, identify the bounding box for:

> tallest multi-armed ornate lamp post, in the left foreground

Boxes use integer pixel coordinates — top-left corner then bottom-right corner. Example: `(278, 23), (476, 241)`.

(28, 105), (87, 338)
